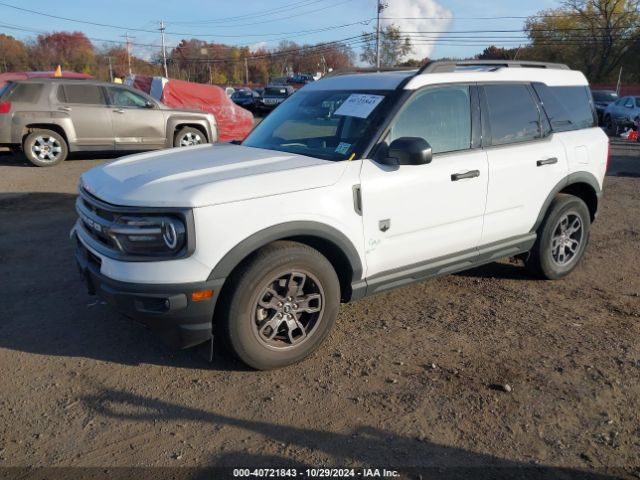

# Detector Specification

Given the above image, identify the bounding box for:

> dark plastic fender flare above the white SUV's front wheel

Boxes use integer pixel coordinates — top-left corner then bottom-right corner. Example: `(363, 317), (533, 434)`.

(207, 221), (362, 282)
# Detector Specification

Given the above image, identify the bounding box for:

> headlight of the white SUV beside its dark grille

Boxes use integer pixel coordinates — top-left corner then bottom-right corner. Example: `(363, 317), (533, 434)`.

(109, 216), (186, 256)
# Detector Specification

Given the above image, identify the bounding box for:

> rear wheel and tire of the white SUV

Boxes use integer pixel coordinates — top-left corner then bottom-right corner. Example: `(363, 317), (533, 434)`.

(526, 194), (591, 280)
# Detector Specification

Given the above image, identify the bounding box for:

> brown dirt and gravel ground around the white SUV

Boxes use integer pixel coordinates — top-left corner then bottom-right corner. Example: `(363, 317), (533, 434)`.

(0, 146), (640, 479)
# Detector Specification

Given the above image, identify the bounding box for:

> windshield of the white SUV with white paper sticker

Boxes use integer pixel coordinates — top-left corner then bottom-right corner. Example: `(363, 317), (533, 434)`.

(242, 90), (389, 160)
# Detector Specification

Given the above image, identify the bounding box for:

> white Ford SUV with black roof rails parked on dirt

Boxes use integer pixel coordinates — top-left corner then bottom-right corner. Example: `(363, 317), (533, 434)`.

(72, 62), (608, 369)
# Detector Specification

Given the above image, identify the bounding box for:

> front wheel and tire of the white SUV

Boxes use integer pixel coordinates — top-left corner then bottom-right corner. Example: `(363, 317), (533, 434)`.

(216, 241), (340, 370)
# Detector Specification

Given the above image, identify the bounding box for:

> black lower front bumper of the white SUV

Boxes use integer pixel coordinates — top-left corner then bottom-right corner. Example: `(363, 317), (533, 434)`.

(72, 233), (224, 348)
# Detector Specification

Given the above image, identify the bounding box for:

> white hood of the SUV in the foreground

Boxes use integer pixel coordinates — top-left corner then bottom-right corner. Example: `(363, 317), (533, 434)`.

(80, 144), (346, 207)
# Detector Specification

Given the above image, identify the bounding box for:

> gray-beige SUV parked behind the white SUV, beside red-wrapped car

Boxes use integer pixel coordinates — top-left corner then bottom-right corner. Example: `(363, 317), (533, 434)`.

(0, 78), (218, 167)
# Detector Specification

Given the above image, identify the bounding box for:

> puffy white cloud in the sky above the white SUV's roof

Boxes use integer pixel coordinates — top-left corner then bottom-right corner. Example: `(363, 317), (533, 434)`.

(381, 0), (453, 59)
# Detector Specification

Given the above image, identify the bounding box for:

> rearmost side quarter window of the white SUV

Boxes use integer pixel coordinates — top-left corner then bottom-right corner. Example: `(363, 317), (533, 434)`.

(533, 83), (597, 132)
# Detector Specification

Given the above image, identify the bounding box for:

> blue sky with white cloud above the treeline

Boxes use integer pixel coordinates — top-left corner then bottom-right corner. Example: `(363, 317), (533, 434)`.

(0, 0), (559, 62)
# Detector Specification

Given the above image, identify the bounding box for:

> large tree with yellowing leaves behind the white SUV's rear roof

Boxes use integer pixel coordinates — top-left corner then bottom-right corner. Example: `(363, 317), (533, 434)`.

(525, 0), (640, 82)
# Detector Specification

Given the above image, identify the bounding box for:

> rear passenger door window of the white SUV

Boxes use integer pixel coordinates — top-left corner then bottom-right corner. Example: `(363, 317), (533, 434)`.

(483, 84), (542, 145)
